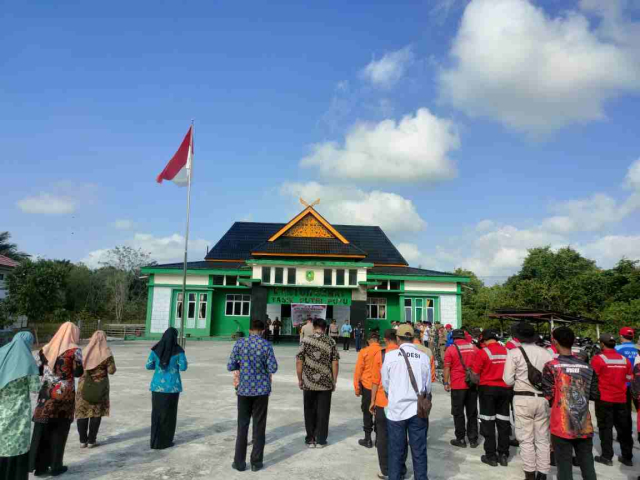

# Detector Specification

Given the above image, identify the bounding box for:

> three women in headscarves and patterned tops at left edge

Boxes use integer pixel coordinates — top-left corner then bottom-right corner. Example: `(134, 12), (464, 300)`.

(0, 322), (116, 480)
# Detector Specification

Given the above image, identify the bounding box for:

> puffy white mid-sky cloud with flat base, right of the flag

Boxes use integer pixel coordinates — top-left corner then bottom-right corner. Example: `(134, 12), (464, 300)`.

(300, 108), (460, 183)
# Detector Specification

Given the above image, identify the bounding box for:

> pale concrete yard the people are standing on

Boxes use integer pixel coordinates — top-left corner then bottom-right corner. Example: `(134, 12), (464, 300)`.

(36, 342), (640, 480)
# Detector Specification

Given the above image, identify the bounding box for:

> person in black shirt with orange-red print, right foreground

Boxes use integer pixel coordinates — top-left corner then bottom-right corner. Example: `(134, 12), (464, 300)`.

(542, 327), (600, 480)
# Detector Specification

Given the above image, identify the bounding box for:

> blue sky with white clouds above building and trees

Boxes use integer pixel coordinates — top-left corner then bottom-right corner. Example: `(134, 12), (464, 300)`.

(0, 0), (640, 281)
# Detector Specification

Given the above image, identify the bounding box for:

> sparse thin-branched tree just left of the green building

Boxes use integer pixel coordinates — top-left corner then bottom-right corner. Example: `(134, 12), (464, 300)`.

(101, 246), (151, 323)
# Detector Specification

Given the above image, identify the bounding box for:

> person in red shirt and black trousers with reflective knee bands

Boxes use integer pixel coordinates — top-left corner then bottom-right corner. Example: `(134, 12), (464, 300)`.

(471, 329), (511, 467)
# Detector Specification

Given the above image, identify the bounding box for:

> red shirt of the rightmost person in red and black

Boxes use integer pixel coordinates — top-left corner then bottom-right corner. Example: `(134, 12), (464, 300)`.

(591, 348), (633, 403)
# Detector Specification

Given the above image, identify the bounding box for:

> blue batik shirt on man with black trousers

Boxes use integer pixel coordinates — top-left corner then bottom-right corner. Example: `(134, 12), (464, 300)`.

(227, 335), (278, 397)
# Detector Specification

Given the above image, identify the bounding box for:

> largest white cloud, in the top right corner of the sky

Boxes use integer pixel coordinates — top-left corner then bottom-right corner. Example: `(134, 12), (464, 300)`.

(439, 0), (640, 135)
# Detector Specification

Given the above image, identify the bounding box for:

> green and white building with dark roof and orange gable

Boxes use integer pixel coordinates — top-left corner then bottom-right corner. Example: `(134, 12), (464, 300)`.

(143, 206), (469, 338)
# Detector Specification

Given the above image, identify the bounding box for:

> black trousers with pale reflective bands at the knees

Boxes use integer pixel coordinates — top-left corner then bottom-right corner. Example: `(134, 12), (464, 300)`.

(478, 386), (511, 460)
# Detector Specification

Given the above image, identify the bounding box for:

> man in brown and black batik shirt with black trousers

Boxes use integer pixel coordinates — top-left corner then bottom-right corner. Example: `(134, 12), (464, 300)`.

(296, 318), (340, 448)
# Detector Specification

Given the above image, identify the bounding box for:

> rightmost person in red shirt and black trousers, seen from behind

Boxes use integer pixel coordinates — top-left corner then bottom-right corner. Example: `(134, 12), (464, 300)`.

(591, 333), (633, 467)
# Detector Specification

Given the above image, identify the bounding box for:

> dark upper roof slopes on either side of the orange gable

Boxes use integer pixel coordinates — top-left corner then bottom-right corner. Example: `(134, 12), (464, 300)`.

(206, 222), (407, 265)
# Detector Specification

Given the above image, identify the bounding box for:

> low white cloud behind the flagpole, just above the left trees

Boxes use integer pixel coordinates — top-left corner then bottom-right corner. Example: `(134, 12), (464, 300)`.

(81, 233), (210, 268)
